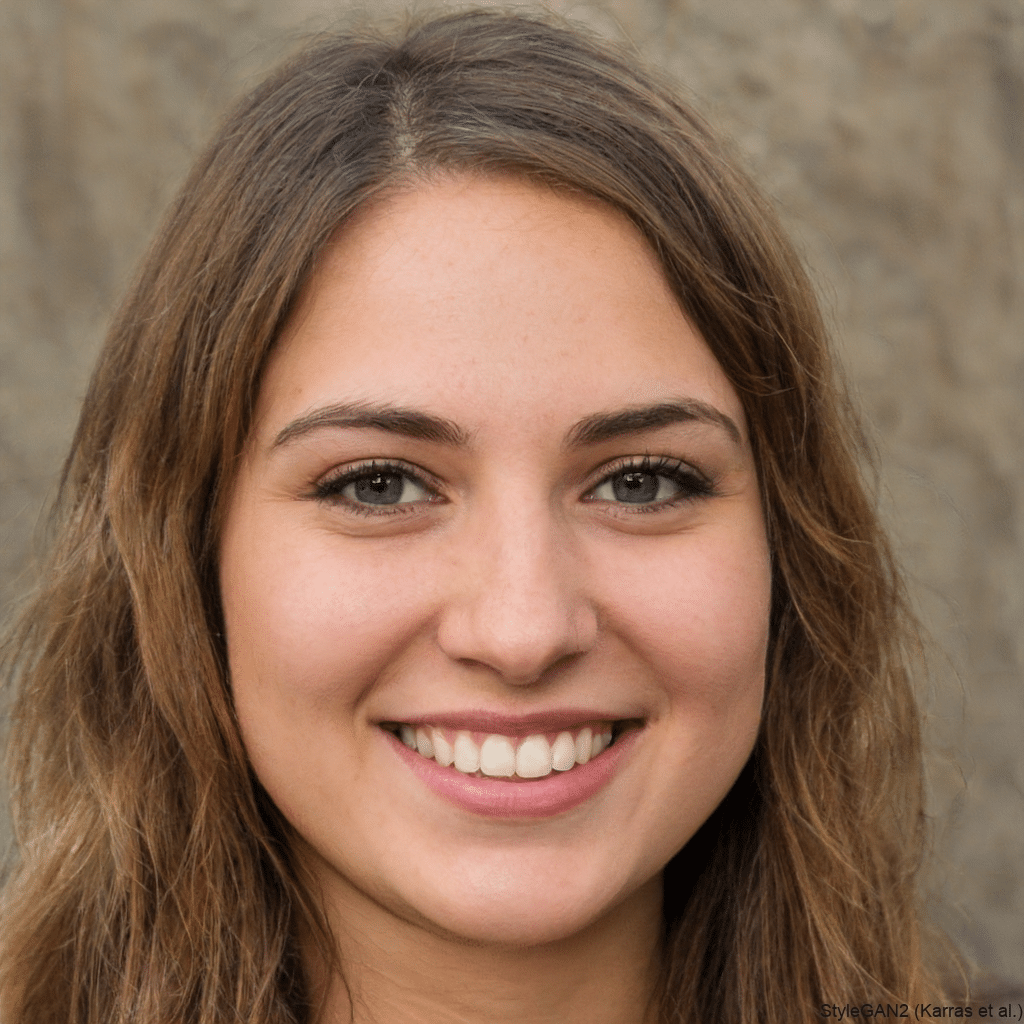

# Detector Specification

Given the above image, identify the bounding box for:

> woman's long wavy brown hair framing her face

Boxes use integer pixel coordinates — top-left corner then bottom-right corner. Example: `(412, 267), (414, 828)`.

(0, 10), (942, 1024)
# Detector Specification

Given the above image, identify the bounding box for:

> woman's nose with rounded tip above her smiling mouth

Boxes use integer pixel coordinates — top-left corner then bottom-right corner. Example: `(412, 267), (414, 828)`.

(437, 497), (598, 685)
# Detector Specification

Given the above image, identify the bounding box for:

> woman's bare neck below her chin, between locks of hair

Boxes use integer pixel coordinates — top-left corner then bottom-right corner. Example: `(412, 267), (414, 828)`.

(306, 878), (662, 1024)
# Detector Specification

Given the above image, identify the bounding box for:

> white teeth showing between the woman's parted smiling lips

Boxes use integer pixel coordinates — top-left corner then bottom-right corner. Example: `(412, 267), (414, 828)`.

(381, 719), (642, 780)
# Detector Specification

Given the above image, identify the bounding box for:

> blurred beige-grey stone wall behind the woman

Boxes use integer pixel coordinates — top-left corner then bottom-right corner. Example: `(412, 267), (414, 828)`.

(0, 0), (1024, 983)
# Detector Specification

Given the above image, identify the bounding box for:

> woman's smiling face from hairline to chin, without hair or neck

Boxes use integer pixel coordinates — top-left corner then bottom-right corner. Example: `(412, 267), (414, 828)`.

(220, 177), (769, 943)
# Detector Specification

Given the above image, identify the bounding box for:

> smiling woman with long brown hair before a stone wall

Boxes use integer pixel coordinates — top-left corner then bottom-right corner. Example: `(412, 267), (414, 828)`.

(0, 12), (931, 1024)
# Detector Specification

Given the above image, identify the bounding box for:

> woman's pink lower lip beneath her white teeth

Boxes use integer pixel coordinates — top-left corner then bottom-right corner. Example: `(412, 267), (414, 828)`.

(385, 729), (641, 818)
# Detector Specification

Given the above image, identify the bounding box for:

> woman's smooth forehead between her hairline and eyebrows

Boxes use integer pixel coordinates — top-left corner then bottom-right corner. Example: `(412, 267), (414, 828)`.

(254, 176), (743, 444)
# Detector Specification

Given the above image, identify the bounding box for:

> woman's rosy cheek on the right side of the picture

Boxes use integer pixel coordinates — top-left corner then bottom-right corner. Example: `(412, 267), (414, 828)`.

(573, 515), (771, 871)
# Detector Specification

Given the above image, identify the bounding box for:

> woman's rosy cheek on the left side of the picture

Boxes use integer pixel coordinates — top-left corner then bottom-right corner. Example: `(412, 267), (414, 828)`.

(220, 505), (438, 835)
